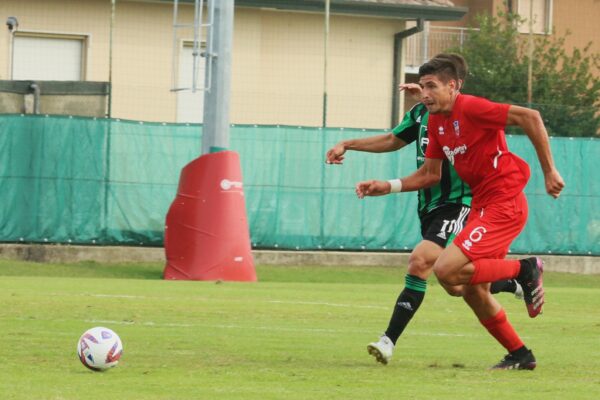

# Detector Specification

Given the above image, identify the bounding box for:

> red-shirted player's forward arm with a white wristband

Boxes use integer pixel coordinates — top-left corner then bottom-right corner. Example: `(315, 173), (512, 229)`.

(355, 158), (442, 199)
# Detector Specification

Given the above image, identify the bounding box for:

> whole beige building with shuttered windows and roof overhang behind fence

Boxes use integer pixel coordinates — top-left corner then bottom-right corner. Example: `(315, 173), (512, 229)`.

(0, 0), (466, 129)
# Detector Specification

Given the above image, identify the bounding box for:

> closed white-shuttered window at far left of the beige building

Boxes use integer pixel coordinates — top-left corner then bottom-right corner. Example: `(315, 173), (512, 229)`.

(12, 32), (87, 81)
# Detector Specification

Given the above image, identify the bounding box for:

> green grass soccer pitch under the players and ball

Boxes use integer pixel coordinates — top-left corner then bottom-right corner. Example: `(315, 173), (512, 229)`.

(0, 261), (600, 400)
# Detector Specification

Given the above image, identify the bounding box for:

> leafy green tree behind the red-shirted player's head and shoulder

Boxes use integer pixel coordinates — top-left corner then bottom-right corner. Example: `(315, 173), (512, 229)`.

(449, 13), (600, 136)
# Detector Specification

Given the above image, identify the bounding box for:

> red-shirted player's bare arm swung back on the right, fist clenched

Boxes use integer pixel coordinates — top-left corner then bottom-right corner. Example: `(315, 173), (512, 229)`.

(506, 106), (565, 199)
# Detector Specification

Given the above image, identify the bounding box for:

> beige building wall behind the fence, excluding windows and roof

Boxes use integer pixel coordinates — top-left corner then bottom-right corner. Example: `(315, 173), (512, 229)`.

(0, 0), (405, 128)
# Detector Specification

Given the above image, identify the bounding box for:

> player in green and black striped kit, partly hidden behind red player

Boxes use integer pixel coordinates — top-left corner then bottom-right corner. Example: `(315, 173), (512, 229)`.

(326, 54), (522, 364)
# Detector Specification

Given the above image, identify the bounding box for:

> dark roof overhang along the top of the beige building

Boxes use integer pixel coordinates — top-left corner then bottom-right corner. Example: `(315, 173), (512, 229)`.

(154, 0), (469, 21)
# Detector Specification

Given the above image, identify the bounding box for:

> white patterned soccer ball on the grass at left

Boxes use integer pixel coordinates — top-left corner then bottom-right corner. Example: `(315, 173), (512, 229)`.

(77, 326), (123, 371)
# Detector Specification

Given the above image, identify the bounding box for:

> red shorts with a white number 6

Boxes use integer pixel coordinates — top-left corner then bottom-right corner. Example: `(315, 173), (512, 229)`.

(453, 193), (528, 261)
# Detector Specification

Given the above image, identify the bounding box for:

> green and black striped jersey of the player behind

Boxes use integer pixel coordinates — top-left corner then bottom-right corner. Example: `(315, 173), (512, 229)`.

(392, 103), (471, 217)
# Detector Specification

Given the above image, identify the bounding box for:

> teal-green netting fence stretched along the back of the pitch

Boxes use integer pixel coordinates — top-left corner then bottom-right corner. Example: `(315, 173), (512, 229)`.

(0, 115), (600, 255)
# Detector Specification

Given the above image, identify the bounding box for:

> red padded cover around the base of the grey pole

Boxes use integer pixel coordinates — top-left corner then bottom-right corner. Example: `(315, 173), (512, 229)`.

(164, 151), (256, 281)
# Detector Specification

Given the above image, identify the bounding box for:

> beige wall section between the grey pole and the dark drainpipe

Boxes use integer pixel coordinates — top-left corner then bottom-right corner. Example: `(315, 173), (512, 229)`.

(232, 9), (404, 128)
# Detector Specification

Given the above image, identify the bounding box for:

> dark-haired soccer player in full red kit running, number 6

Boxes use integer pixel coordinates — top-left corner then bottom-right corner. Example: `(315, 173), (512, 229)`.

(356, 57), (564, 369)
